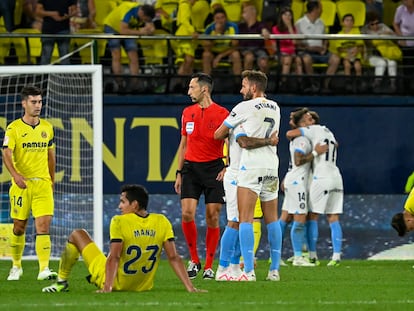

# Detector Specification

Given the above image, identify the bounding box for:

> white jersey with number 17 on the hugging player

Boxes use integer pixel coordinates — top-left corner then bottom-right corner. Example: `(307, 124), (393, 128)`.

(300, 125), (338, 175)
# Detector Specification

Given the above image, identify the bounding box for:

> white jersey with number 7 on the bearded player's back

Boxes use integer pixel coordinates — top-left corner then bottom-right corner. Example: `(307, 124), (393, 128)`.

(224, 97), (280, 169)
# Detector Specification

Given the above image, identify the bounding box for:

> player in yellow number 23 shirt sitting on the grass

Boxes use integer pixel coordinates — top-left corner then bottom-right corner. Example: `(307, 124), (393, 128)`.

(43, 185), (205, 293)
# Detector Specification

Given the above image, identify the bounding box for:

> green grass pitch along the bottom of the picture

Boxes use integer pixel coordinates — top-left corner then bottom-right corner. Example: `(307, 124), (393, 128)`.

(0, 260), (414, 311)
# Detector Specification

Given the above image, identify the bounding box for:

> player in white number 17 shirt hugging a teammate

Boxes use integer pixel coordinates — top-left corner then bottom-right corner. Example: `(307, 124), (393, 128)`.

(286, 114), (344, 266)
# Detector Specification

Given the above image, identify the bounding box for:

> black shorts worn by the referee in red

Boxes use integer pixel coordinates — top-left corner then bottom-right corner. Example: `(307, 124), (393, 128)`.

(181, 158), (224, 204)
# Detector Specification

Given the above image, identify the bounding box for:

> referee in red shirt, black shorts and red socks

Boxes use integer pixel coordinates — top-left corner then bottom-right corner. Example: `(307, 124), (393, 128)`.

(174, 73), (229, 279)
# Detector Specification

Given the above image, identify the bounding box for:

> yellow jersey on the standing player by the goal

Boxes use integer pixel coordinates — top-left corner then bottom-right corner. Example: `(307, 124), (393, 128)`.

(3, 119), (54, 180)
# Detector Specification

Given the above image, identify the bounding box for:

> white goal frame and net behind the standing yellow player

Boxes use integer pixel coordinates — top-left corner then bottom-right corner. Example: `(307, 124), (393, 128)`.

(0, 65), (103, 257)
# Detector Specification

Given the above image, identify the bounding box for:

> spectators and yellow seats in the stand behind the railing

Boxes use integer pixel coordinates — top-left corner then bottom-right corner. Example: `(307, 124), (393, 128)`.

(0, 0), (414, 94)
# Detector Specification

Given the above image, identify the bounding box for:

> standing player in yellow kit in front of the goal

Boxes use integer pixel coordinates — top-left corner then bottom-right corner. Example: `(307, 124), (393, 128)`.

(3, 86), (57, 281)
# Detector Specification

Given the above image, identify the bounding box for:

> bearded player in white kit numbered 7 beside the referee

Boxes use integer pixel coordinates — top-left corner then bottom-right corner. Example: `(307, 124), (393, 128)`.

(215, 70), (282, 281)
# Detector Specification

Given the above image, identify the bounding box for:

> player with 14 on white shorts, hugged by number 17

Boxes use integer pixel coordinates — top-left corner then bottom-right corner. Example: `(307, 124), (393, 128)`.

(279, 108), (328, 267)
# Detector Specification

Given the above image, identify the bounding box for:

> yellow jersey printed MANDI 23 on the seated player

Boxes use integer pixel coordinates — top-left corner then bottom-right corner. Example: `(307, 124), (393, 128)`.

(109, 213), (174, 291)
